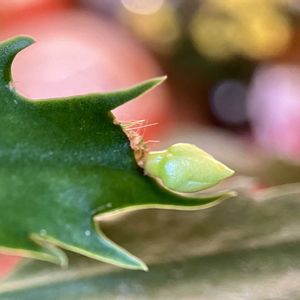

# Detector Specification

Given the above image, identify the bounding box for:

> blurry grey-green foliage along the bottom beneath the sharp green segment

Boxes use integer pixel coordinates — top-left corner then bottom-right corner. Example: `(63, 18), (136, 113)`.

(0, 185), (300, 300)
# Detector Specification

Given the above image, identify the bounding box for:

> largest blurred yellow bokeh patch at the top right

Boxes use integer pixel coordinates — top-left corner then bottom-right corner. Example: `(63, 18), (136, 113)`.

(190, 0), (291, 60)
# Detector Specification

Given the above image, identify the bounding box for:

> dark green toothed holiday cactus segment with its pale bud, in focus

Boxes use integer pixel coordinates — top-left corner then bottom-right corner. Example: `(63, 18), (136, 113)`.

(0, 37), (233, 270)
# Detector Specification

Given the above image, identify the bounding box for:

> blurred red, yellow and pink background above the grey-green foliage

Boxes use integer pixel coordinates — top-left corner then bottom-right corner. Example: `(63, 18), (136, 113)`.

(0, 0), (300, 273)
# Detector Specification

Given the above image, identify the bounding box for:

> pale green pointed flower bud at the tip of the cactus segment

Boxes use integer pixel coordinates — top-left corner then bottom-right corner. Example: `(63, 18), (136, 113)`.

(145, 144), (234, 193)
